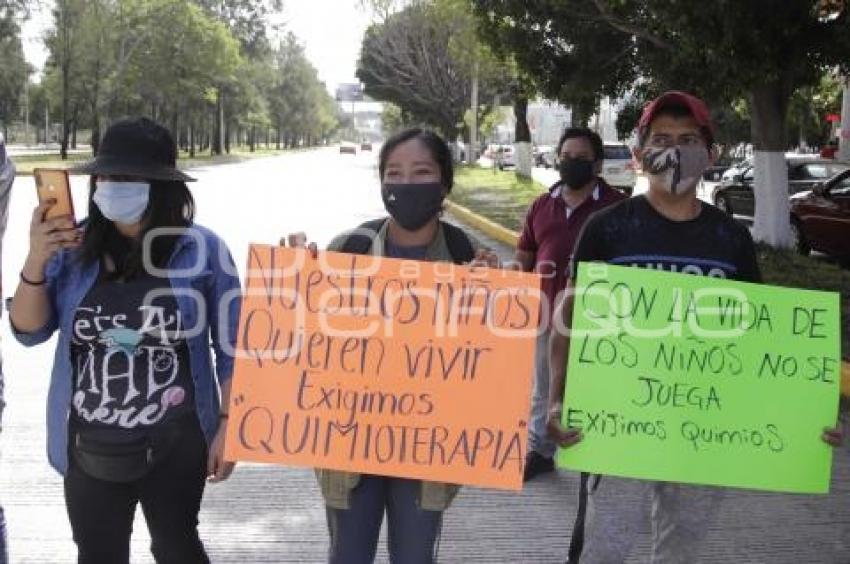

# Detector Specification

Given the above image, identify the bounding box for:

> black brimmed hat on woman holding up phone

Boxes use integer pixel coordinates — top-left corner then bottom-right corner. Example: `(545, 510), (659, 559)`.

(72, 118), (195, 182)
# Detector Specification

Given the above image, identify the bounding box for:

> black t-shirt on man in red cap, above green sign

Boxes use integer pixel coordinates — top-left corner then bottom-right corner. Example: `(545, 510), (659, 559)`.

(571, 196), (761, 282)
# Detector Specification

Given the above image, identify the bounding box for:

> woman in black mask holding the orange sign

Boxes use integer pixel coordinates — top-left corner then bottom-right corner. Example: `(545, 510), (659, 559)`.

(289, 129), (498, 564)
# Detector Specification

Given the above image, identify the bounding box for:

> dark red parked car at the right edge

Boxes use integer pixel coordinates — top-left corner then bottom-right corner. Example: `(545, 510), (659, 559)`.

(791, 169), (850, 262)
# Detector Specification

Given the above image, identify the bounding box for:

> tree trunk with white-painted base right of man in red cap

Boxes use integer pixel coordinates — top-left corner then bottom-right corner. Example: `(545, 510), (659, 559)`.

(749, 81), (791, 247)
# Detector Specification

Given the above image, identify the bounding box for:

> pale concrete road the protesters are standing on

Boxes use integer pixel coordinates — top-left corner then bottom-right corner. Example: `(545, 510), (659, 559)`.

(0, 149), (850, 564)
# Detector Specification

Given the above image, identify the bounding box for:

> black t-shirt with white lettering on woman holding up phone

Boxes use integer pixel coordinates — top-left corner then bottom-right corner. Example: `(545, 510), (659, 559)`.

(71, 276), (195, 439)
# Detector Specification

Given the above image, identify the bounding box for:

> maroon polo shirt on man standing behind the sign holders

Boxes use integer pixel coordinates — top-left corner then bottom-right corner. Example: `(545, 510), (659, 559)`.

(517, 178), (625, 321)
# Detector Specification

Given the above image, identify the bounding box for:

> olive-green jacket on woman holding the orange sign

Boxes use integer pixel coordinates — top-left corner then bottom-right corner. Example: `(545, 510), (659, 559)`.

(316, 222), (460, 511)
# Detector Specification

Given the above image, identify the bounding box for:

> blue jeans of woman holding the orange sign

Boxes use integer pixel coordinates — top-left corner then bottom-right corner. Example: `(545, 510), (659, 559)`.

(327, 475), (443, 564)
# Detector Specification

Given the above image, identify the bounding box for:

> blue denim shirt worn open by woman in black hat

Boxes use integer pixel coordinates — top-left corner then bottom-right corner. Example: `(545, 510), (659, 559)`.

(12, 225), (241, 475)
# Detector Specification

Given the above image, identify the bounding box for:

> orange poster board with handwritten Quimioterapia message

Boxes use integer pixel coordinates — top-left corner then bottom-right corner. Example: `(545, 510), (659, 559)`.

(225, 245), (540, 490)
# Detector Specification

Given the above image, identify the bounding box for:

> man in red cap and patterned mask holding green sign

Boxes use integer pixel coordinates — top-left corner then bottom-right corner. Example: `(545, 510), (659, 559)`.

(548, 92), (841, 564)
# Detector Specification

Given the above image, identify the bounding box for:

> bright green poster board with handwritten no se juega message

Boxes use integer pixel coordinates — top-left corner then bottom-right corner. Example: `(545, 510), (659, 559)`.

(557, 263), (841, 493)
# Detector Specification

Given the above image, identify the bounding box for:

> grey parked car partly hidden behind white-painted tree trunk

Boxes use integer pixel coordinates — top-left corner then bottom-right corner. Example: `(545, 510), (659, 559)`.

(712, 157), (850, 217)
